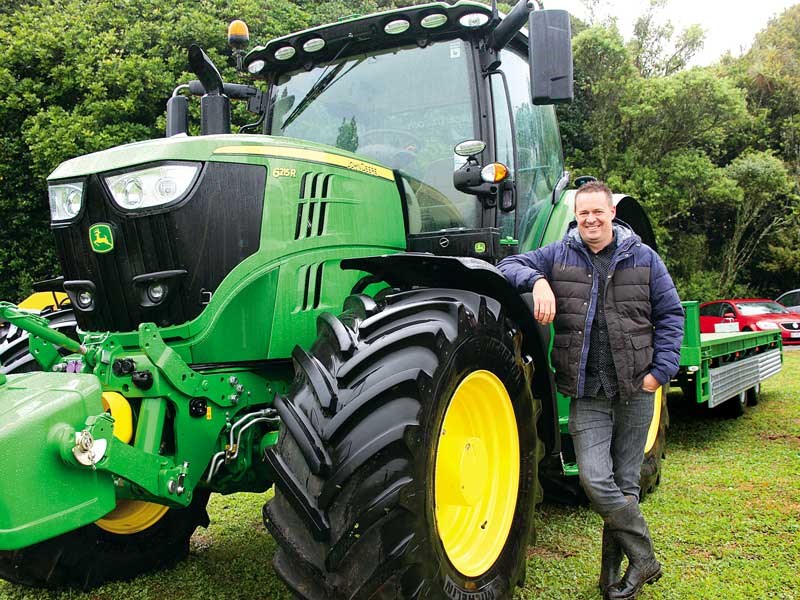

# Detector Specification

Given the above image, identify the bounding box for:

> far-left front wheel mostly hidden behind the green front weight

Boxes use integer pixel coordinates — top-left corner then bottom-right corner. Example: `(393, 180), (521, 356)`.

(0, 308), (209, 590)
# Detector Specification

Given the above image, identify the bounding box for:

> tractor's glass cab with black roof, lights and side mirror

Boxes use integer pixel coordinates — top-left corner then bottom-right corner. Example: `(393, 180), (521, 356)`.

(243, 2), (572, 260)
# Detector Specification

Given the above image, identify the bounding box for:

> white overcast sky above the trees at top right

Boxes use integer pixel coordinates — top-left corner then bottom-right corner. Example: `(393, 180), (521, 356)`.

(544, 0), (799, 65)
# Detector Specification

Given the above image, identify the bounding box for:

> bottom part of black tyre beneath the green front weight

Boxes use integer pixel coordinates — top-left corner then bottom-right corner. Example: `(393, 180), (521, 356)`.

(0, 489), (209, 590)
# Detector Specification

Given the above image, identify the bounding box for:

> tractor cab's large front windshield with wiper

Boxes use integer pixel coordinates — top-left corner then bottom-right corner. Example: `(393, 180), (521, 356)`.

(269, 40), (480, 233)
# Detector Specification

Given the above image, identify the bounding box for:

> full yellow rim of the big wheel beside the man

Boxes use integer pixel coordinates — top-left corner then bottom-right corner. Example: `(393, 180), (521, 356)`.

(433, 371), (520, 577)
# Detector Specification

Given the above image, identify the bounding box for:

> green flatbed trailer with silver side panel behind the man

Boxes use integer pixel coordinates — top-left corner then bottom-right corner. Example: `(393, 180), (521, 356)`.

(673, 302), (783, 416)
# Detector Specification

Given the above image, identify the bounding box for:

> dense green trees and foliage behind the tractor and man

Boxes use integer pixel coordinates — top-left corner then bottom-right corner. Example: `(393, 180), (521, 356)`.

(0, 0), (800, 300)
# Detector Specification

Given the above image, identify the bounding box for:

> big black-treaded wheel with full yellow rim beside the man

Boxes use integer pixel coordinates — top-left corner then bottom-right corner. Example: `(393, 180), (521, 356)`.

(264, 289), (543, 599)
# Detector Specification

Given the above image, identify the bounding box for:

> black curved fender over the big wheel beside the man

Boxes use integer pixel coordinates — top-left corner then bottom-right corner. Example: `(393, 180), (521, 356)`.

(342, 252), (561, 454)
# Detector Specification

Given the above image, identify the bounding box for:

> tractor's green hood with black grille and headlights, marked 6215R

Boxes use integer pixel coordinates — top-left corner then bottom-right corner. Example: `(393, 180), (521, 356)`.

(40, 134), (406, 344)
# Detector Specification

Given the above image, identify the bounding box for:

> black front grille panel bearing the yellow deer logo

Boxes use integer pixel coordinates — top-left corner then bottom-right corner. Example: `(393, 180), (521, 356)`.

(53, 163), (266, 331)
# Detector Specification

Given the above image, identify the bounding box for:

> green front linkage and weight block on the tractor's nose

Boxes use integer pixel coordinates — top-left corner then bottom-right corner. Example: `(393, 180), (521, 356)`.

(0, 302), (287, 549)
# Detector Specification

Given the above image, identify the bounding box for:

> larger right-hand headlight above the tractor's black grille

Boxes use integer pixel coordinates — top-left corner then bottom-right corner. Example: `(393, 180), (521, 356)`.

(103, 163), (200, 210)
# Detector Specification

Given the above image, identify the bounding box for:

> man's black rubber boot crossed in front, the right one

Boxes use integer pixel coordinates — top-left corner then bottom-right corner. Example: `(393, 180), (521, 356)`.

(604, 500), (661, 600)
